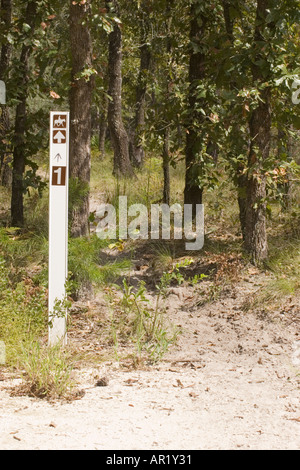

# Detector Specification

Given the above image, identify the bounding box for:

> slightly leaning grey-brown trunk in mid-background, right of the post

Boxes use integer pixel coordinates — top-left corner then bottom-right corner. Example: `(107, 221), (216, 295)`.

(107, 0), (133, 176)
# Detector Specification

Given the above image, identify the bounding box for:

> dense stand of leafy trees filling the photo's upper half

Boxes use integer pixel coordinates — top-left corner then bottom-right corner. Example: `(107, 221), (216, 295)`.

(0, 0), (300, 263)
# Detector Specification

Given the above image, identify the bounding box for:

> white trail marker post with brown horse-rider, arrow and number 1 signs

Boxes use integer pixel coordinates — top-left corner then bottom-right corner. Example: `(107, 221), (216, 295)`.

(48, 111), (69, 345)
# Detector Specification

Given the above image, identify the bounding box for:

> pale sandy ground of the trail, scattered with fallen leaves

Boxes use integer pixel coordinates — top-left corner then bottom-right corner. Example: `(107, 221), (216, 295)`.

(0, 258), (300, 450)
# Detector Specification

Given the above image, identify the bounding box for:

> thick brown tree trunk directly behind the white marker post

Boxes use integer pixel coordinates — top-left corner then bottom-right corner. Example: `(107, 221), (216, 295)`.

(70, 0), (94, 237)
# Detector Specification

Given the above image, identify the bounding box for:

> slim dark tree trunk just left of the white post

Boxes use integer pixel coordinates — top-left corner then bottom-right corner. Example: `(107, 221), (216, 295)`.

(11, 1), (37, 227)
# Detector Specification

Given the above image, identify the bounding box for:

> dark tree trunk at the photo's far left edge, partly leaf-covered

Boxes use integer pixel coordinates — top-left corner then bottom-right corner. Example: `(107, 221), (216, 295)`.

(0, 0), (12, 187)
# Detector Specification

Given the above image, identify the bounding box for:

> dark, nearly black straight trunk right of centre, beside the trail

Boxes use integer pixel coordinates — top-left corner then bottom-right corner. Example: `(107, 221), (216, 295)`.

(184, 1), (207, 215)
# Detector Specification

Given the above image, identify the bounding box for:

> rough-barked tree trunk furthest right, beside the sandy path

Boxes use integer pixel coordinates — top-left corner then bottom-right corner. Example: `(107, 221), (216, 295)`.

(245, 0), (272, 264)
